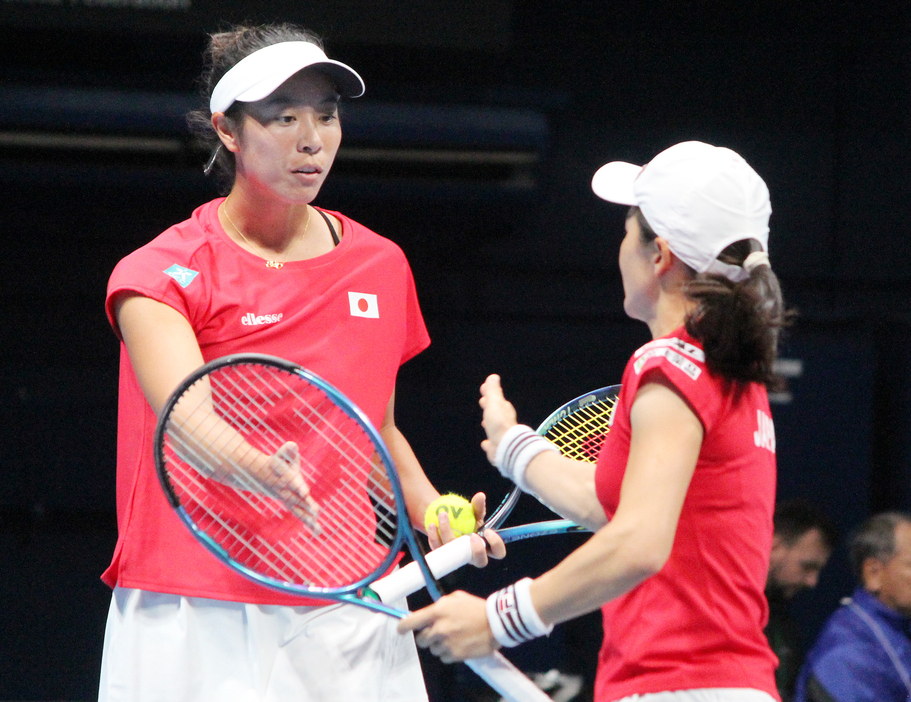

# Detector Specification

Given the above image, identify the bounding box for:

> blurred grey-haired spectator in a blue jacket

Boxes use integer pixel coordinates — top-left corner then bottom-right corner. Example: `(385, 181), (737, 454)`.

(796, 512), (911, 702)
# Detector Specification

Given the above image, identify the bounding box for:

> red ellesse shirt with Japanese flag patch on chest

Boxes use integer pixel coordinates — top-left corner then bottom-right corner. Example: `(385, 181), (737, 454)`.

(102, 199), (430, 605)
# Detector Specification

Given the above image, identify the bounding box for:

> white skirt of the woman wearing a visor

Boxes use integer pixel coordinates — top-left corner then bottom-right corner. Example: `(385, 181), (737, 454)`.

(98, 588), (427, 702)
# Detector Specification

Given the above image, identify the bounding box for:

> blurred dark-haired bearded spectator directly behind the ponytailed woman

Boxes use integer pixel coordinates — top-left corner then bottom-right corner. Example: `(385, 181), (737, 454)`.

(765, 500), (838, 702)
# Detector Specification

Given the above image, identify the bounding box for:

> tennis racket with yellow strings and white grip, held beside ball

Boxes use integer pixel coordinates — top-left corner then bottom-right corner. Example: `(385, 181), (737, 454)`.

(371, 385), (620, 602)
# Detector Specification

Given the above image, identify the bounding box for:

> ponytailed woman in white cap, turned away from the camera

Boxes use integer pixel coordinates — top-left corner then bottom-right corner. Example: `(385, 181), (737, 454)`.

(399, 142), (788, 702)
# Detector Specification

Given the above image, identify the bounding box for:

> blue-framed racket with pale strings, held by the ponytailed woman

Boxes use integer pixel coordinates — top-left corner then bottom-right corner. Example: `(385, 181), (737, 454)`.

(155, 354), (550, 702)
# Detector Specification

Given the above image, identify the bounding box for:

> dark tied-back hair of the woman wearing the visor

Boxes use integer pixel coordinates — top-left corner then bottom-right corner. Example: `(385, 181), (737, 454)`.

(187, 23), (323, 192)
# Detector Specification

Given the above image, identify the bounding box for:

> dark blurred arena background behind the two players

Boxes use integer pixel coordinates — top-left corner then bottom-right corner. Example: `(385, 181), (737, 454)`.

(0, 0), (911, 700)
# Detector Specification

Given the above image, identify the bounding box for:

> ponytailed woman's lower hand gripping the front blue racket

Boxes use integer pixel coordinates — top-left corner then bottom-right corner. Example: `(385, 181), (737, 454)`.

(398, 591), (500, 663)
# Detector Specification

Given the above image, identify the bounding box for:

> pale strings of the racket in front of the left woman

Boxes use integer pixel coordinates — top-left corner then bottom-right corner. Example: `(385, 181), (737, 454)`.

(165, 366), (398, 588)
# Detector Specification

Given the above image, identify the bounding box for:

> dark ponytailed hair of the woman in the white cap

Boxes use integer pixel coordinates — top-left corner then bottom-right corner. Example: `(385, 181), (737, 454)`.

(627, 206), (793, 390)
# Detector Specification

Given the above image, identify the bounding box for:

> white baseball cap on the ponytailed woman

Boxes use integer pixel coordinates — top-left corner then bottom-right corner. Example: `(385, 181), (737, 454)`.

(592, 141), (772, 281)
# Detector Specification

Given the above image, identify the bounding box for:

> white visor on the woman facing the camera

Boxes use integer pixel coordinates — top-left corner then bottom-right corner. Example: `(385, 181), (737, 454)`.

(209, 41), (364, 114)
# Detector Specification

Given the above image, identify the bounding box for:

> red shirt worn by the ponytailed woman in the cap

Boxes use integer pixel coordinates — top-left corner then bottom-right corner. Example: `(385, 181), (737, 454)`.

(595, 328), (778, 702)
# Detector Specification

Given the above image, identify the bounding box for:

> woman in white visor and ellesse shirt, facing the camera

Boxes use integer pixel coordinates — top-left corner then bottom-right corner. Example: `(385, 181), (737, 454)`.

(99, 25), (503, 702)
